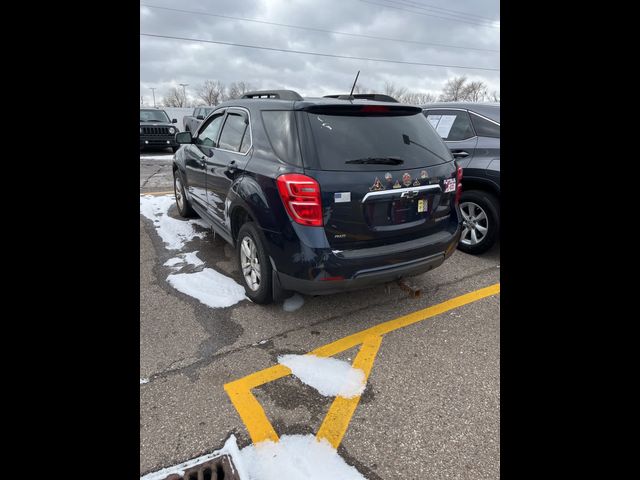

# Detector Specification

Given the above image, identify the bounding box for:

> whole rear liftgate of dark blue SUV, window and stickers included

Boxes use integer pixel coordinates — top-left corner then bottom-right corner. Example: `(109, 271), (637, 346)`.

(299, 102), (456, 249)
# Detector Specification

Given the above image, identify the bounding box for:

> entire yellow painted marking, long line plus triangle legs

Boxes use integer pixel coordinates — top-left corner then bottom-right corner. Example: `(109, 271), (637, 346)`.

(224, 283), (500, 448)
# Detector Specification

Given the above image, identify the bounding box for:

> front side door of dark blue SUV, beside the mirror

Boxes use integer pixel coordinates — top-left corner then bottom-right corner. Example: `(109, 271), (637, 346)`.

(185, 110), (225, 207)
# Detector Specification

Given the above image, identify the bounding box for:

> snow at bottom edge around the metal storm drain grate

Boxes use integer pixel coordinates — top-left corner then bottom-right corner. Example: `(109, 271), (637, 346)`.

(140, 435), (366, 480)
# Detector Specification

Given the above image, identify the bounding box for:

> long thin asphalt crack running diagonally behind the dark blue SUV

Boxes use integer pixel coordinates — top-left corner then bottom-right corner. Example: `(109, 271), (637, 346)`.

(148, 266), (496, 383)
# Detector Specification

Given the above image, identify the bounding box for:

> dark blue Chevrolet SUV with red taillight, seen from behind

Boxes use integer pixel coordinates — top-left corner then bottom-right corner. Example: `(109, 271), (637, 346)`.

(173, 90), (462, 303)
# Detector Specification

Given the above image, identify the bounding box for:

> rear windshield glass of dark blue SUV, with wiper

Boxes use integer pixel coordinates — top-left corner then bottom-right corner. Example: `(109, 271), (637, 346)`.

(307, 113), (452, 171)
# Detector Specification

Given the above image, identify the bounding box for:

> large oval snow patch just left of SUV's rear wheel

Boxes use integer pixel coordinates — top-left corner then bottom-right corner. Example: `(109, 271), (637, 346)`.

(167, 268), (246, 308)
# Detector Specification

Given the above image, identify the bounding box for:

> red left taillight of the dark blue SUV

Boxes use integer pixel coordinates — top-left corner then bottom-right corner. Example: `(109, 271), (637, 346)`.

(277, 173), (322, 227)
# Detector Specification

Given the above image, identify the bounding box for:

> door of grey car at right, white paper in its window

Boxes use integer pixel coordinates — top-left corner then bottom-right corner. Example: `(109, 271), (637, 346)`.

(424, 108), (478, 169)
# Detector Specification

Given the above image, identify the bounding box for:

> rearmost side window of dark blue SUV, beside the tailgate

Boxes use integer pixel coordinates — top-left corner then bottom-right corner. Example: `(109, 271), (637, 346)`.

(261, 110), (302, 166)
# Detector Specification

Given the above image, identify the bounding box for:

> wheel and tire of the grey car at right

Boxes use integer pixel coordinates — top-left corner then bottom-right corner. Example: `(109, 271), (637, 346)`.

(458, 190), (500, 255)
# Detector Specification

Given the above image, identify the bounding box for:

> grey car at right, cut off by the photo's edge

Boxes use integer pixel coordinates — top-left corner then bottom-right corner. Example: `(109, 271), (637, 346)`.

(423, 102), (500, 254)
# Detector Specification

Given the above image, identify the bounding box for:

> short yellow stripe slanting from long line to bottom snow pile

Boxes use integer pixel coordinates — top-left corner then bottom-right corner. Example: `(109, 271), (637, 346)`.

(316, 337), (382, 449)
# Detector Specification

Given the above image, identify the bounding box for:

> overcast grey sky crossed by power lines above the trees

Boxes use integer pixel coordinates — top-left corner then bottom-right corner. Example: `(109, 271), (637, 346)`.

(140, 0), (500, 105)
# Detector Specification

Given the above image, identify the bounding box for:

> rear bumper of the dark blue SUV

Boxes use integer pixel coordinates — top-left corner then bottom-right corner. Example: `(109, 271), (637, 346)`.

(272, 224), (461, 295)
